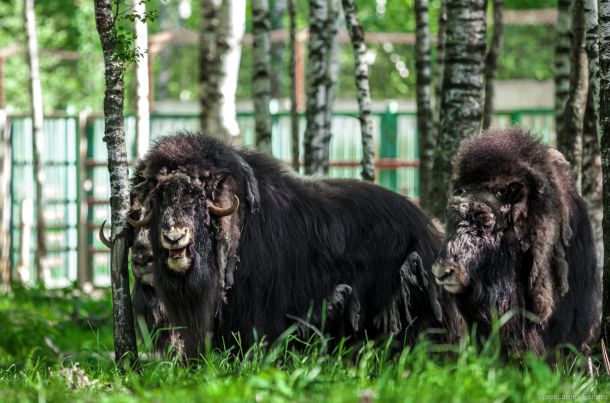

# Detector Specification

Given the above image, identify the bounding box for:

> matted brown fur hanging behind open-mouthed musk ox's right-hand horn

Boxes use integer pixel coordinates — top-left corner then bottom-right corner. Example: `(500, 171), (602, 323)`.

(214, 176), (241, 299)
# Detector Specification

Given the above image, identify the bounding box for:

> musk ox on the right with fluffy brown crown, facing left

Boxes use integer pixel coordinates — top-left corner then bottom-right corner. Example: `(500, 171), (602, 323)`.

(433, 128), (601, 354)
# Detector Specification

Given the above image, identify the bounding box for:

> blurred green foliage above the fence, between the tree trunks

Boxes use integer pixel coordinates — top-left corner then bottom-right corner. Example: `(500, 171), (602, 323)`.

(0, 0), (557, 113)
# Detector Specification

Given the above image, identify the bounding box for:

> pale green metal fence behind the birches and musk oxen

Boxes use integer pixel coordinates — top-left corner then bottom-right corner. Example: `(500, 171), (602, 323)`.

(11, 108), (554, 287)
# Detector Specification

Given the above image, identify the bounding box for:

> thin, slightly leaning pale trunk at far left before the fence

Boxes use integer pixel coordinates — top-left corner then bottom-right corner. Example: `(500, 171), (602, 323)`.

(23, 0), (47, 282)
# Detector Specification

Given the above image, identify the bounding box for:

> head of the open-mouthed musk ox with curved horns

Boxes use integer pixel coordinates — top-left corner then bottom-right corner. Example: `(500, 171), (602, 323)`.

(129, 134), (258, 300)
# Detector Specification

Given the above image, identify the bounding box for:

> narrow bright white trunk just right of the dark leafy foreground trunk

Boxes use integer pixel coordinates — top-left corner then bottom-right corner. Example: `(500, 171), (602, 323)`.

(133, 0), (150, 158)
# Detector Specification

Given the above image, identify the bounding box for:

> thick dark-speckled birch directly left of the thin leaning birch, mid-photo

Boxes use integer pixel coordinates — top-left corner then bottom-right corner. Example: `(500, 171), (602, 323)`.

(304, 0), (338, 176)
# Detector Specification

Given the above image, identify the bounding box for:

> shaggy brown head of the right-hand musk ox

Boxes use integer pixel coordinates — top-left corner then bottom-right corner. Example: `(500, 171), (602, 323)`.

(433, 128), (573, 323)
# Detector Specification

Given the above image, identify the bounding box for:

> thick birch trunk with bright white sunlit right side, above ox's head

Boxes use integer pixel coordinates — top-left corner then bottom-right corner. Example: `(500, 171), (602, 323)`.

(199, 0), (246, 139)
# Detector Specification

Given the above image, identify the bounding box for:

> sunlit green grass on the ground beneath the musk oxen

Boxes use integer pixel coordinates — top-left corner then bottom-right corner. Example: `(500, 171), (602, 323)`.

(0, 289), (610, 402)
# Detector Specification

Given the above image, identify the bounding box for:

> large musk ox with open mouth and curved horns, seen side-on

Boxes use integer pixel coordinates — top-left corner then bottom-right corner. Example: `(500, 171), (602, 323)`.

(130, 134), (457, 357)
